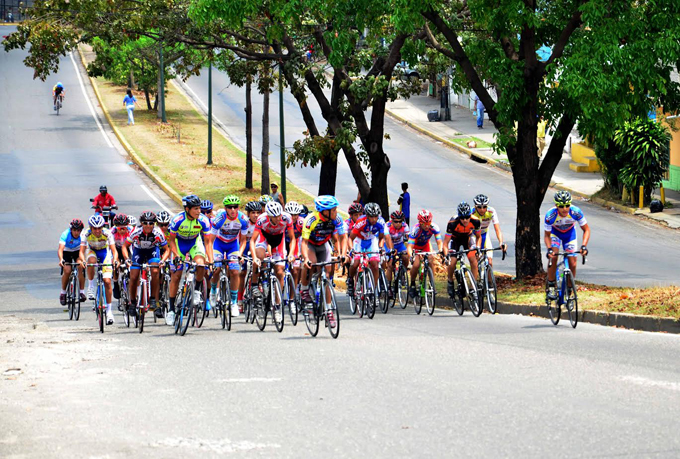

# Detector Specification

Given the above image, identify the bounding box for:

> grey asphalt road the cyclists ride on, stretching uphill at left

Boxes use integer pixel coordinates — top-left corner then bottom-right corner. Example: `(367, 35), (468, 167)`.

(0, 29), (680, 458)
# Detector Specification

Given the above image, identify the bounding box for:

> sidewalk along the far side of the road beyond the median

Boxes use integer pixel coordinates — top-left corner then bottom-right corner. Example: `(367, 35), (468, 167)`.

(386, 95), (680, 228)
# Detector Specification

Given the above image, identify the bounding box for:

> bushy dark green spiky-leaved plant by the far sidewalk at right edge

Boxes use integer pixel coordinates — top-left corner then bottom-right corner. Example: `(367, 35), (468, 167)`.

(614, 118), (671, 200)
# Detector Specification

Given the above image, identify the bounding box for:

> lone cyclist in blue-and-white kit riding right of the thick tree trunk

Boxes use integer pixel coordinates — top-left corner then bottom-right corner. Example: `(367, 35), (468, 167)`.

(544, 191), (590, 300)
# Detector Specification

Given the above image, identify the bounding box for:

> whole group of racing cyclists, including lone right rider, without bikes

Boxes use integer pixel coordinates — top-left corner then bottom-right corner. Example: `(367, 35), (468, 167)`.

(58, 183), (590, 324)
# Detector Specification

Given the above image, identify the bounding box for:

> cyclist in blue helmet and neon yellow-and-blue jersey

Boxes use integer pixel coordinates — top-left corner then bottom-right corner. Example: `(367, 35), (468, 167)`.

(166, 194), (213, 323)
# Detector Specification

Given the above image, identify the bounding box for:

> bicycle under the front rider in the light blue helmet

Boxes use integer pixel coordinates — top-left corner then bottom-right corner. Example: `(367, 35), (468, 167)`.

(302, 258), (341, 339)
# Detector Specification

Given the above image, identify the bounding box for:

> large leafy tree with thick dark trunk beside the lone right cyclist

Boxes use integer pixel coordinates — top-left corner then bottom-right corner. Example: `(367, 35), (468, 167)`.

(412, 0), (680, 278)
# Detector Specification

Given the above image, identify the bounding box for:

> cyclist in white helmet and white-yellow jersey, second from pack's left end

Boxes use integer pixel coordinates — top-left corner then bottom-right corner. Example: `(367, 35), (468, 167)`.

(80, 214), (118, 325)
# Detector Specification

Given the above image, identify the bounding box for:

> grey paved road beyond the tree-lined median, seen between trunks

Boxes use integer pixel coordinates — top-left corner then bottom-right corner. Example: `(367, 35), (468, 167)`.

(181, 71), (680, 286)
